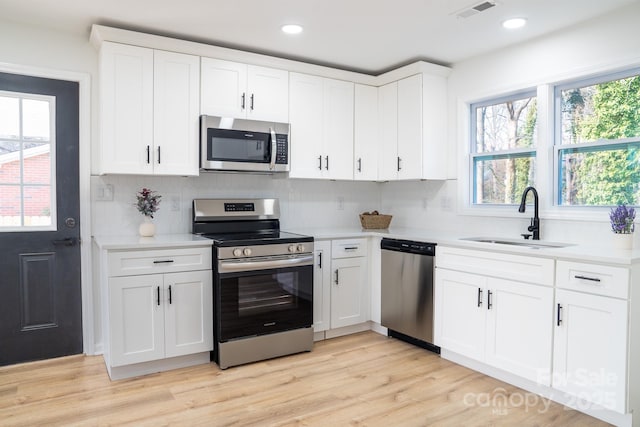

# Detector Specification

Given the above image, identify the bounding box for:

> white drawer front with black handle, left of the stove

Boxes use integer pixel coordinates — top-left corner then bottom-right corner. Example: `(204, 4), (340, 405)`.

(109, 247), (211, 277)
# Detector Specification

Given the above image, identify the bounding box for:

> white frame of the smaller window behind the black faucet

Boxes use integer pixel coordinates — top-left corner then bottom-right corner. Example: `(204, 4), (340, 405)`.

(466, 86), (540, 209)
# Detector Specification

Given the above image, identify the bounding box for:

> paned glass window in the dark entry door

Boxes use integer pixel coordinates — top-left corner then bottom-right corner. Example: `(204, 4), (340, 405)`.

(0, 91), (55, 231)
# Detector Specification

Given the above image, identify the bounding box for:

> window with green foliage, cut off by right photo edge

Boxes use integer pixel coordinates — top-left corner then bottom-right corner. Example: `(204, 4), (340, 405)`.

(555, 70), (640, 206)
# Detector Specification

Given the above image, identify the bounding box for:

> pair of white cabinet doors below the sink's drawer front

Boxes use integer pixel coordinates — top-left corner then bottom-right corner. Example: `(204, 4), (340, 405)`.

(435, 269), (553, 385)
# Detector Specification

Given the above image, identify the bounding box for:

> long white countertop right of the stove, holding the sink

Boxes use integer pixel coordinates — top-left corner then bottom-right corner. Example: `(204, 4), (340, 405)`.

(287, 227), (640, 266)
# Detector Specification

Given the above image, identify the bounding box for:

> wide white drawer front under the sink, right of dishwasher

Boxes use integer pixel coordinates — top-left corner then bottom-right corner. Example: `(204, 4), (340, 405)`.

(436, 246), (554, 286)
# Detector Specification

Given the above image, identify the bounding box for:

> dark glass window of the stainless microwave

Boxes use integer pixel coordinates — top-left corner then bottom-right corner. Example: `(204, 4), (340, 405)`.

(207, 129), (271, 163)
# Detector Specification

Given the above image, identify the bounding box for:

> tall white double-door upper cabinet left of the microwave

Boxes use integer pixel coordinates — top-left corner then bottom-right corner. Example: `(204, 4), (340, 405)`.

(100, 42), (200, 175)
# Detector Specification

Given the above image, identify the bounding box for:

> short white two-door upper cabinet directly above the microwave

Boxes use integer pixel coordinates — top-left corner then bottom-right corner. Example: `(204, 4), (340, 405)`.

(200, 58), (289, 123)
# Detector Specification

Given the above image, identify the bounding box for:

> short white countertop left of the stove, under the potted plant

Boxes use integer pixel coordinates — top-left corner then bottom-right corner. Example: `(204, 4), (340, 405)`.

(93, 233), (213, 250)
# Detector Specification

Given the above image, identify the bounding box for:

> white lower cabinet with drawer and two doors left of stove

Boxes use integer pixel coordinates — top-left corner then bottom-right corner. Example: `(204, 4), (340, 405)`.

(99, 241), (213, 379)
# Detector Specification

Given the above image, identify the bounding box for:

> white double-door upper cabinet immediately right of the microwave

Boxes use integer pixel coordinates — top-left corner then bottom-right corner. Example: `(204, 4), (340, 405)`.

(289, 73), (354, 180)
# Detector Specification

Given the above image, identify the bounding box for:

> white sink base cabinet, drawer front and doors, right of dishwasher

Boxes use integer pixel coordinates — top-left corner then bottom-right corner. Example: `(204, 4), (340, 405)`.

(434, 246), (553, 385)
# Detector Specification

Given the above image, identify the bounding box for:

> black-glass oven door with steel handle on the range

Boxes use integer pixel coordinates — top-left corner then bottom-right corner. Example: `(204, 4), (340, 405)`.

(214, 254), (313, 342)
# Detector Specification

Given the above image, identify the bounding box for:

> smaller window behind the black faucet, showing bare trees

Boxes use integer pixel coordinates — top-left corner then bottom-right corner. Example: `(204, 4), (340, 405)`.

(471, 91), (537, 205)
